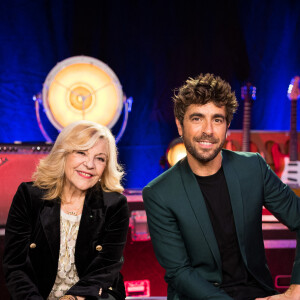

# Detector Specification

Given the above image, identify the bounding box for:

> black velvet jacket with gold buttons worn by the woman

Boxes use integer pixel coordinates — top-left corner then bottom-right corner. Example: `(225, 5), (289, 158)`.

(3, 183), (129, 300)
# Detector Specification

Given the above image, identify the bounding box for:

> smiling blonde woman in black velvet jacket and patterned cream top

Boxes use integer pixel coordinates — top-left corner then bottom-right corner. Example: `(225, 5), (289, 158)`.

(3, 121), (129, 300)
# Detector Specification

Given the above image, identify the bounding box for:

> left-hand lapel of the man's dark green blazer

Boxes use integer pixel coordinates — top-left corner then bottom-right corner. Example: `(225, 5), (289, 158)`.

(180, 158), (222, 269)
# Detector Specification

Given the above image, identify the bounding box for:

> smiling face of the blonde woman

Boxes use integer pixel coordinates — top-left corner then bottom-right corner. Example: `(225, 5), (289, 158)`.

(64, 139), (108, 192)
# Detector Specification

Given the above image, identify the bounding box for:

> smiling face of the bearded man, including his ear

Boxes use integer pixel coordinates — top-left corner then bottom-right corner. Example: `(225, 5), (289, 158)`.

(176, 102), (228, 163)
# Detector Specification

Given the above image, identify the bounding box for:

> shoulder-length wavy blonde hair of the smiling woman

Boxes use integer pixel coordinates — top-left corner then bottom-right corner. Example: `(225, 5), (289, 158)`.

(32, 121), (124, 200)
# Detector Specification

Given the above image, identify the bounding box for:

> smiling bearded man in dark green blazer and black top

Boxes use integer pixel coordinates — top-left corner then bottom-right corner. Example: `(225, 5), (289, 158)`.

(143, 74), (300, 300)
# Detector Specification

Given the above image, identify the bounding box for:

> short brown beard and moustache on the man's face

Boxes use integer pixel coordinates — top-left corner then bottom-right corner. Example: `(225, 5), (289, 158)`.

(182, 133), (226, 163)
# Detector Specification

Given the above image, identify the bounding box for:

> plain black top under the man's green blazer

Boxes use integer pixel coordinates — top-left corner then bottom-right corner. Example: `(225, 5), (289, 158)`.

(195, 167), (269, 300)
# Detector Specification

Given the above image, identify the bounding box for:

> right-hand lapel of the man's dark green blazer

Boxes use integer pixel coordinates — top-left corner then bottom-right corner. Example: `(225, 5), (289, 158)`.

(222, 150), (247, 263)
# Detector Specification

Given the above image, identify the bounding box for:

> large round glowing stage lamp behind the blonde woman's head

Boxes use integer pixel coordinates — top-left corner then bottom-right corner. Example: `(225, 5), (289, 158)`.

(34, 56), (126, 136)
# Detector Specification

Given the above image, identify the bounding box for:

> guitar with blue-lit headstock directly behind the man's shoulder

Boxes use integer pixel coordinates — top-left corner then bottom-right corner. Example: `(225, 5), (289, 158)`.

(241, 82), (258, 152)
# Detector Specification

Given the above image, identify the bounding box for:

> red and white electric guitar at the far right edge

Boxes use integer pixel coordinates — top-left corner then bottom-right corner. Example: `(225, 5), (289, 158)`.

(272, 76), (300, 189)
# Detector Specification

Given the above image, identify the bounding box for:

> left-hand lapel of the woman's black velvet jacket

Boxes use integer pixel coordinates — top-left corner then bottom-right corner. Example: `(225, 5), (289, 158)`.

(40, 200), (60, 264)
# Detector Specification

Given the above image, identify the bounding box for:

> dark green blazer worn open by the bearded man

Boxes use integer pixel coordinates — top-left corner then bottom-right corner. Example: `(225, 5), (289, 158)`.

(143, 150), (300, 300)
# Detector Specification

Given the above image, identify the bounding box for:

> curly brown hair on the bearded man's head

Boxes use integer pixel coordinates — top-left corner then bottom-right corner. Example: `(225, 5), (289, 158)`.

(173, 73), (238, 125)
